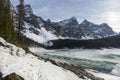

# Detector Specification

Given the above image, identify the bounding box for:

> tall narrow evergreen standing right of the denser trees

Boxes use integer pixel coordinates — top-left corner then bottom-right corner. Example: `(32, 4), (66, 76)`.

(17, 0), (28, 51)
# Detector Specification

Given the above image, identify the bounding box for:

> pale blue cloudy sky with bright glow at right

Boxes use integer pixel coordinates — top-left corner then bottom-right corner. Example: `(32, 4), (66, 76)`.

(11, 0), (120, 32)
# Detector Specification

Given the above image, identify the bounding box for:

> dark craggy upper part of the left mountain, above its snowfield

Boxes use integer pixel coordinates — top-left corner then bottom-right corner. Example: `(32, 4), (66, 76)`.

(14, 0), (44, 29)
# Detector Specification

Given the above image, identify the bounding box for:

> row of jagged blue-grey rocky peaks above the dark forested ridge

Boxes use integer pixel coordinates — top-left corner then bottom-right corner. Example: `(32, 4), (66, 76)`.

(45, 17), (115, 39)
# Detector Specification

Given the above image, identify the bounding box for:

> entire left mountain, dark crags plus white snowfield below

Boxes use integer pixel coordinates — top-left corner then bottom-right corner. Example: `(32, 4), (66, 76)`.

(14, 4), (58, 44)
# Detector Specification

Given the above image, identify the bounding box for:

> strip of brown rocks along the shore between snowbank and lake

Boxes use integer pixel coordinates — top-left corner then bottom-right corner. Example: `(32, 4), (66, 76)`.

(42, 58), (104, 80)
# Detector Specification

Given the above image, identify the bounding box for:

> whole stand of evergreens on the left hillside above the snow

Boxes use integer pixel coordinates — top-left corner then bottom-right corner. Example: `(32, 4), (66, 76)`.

(0, 0), (43, 51)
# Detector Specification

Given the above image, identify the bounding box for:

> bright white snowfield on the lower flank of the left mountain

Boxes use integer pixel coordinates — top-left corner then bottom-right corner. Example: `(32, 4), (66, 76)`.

(23, 23), (58, 44)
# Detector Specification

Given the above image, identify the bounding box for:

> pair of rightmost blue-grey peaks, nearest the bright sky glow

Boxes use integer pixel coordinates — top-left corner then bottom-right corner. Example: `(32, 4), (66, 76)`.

(78, 20), (115, 38)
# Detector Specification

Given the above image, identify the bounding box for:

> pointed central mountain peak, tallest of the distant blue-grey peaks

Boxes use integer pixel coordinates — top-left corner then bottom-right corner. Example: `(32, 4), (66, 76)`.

(58, 17), (82, 39)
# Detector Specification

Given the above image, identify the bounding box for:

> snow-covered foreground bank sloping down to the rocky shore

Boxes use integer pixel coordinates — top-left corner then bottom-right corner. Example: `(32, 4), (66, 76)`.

(0, 38), (82, 80)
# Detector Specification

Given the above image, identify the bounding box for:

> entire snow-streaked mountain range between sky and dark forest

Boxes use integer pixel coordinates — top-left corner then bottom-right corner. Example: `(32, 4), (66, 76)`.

(15, 4), (116, 43)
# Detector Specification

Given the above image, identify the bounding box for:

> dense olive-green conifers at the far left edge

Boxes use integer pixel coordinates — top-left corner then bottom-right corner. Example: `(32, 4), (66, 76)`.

(0, 0), (17, 42)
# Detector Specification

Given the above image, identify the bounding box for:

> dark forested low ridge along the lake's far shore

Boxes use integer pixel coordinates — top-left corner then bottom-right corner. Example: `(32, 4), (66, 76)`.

(47, 35), (120, 49)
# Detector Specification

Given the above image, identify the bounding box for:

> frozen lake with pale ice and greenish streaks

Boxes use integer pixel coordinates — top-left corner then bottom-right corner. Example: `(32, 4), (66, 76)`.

(36, 49), (120, 76)
